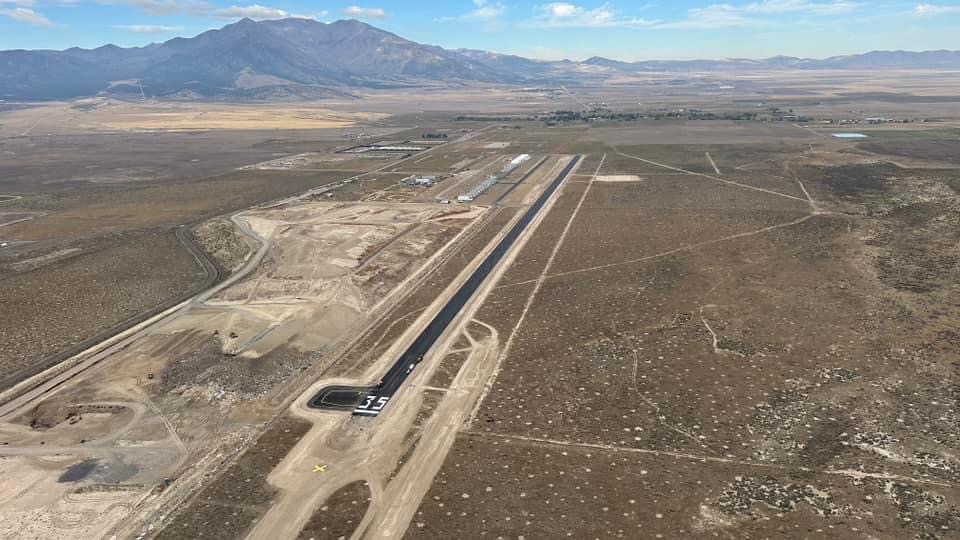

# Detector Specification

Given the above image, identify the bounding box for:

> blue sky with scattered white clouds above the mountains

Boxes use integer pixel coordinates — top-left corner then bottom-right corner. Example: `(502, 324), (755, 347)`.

(0, 0), (960, 60)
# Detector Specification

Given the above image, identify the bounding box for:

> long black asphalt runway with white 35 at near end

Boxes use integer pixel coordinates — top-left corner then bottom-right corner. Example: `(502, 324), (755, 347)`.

(310, 156), (582, 416)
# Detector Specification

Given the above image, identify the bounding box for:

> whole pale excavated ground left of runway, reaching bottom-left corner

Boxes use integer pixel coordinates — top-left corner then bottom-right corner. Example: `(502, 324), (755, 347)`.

(0, 167), (482, 538)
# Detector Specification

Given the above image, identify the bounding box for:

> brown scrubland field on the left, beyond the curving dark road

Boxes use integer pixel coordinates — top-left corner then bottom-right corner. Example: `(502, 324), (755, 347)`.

(0, 168), (368, 384)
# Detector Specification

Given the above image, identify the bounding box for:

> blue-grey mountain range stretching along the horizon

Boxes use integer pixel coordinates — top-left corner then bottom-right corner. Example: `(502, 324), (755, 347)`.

(0, 18), (960, 101)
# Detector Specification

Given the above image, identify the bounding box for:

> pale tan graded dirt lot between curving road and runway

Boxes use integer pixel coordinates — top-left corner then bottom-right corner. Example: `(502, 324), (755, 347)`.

(176, 202), (471, 358)
